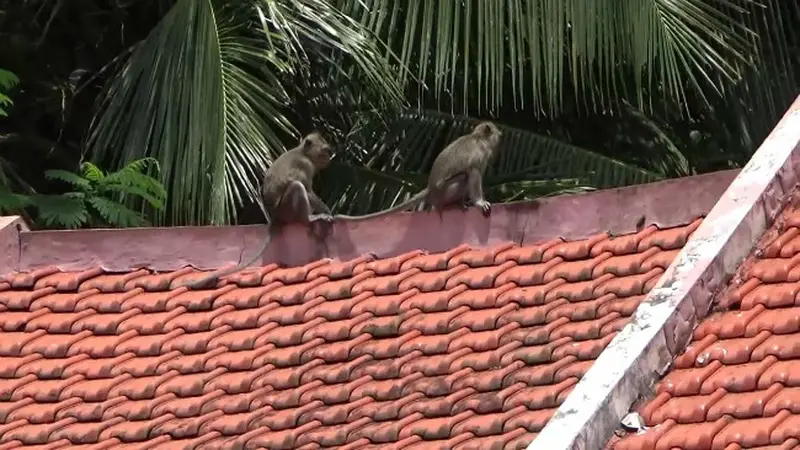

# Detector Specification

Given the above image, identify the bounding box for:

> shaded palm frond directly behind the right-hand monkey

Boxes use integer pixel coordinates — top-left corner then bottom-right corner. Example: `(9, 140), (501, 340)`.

(318, 111), (662, 215)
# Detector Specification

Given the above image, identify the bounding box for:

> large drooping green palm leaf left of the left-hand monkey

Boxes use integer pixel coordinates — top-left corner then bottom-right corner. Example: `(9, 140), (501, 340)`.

(87, 0), (406, 224)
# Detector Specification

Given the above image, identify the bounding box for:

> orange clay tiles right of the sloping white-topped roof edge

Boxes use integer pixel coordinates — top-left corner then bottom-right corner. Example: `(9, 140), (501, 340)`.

(609, 211), (800, 450)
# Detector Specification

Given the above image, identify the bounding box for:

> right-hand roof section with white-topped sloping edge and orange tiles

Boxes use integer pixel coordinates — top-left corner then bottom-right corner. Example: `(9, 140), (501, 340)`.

(528, 93), (800, 450)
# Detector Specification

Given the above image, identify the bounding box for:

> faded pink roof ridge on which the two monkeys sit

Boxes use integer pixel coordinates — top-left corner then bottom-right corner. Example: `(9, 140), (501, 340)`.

(0, 170), (738, 276)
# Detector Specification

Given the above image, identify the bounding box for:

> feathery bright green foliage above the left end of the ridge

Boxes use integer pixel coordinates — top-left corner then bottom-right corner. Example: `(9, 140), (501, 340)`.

(0, 158), (167, 229)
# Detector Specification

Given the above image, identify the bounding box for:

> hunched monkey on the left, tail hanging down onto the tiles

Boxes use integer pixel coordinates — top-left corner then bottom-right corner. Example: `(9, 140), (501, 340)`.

(188, 132), (333, 289)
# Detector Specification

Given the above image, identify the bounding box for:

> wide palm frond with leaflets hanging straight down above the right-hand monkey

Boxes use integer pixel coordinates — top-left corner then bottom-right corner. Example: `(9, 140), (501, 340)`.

(337, 0), (764, 114)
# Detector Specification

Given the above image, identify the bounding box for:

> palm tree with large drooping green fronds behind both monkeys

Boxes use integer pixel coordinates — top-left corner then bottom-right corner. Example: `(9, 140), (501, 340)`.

(87, 0), (795, 224)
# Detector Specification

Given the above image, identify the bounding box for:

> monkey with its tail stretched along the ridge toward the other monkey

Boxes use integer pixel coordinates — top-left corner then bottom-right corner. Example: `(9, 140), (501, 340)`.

(335, 122), (503, 220)
